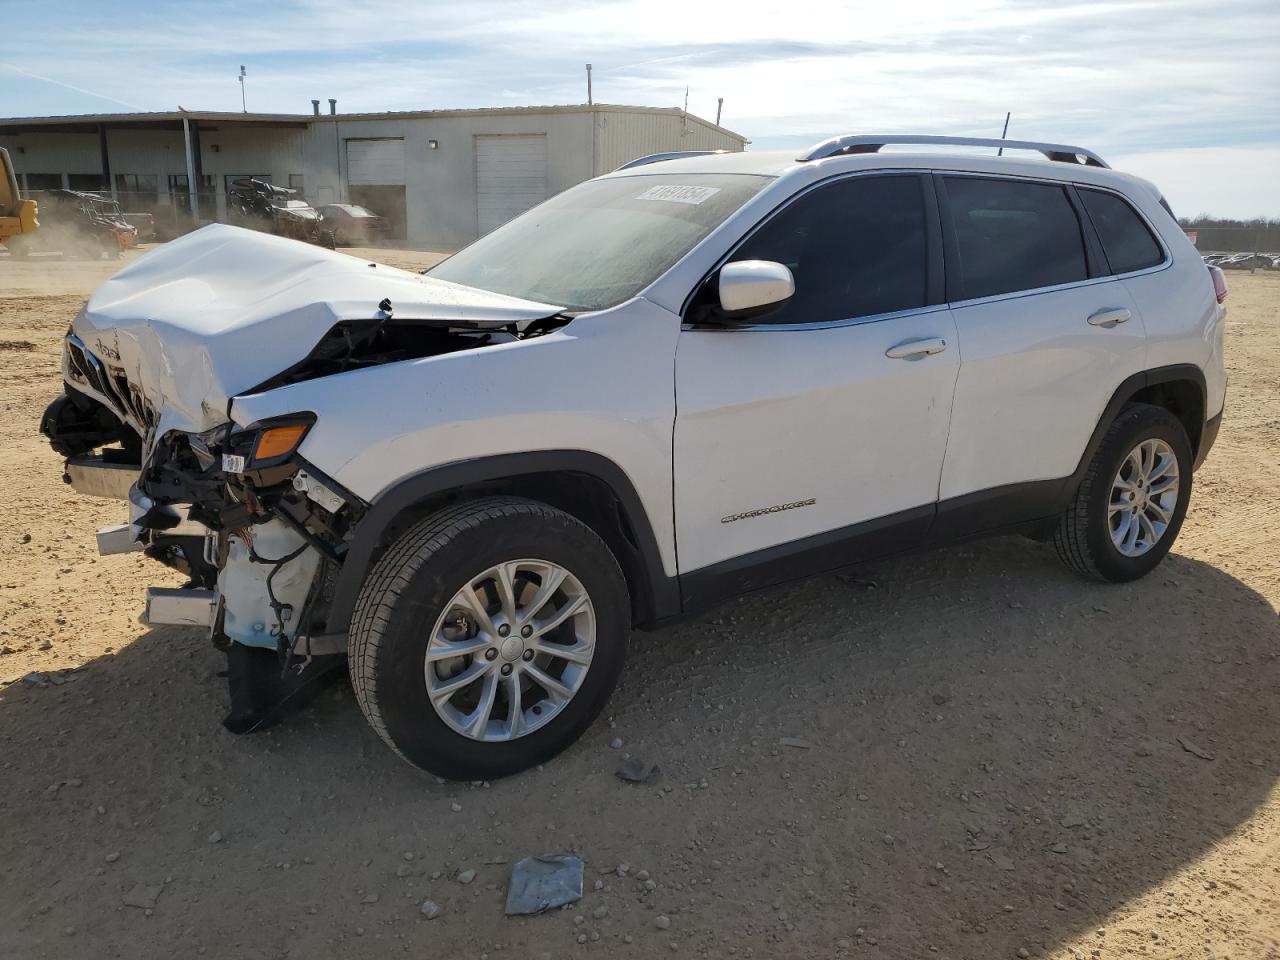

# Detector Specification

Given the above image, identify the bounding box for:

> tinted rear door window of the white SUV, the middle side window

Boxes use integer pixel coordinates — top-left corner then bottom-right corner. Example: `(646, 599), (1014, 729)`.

(945, 177), (1088, 300)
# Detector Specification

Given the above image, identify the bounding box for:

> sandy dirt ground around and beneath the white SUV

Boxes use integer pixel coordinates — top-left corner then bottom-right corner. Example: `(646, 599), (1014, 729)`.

(0, 251), (1280, 960)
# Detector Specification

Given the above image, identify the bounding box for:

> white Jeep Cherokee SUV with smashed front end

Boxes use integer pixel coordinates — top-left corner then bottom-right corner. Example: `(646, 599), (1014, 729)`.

(42, 137), (1226, 778)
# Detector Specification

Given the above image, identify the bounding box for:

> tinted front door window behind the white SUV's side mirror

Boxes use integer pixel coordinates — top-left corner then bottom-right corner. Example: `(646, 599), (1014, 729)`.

(732, 174), (927, 324)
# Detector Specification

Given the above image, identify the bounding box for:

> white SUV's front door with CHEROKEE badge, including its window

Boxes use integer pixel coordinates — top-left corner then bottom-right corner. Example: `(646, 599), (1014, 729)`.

(673, 168), (960, 603)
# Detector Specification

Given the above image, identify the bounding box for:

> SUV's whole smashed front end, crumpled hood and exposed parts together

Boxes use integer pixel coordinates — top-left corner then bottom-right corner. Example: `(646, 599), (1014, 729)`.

(41, 225), (567, 732)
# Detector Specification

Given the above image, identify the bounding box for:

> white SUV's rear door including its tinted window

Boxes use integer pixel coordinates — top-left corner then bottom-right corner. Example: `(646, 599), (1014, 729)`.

(936, 174), (1146, 506)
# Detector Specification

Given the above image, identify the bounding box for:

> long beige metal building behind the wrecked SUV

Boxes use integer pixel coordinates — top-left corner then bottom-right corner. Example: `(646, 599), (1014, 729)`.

(0, 101), (748, 250)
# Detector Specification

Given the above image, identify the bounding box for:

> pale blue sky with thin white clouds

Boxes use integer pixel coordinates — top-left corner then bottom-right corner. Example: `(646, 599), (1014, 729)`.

(0, 0), (1280, 218)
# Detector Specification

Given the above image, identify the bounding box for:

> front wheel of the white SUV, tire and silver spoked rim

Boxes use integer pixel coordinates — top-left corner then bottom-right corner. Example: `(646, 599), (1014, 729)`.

(348, 497), (630, 780)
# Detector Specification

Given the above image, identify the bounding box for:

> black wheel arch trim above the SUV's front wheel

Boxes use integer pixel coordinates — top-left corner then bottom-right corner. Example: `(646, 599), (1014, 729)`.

(324, 449), (681, 635)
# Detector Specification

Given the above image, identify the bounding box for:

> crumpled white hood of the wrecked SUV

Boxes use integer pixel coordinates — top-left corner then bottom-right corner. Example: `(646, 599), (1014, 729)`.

(72, 224), (561, 435)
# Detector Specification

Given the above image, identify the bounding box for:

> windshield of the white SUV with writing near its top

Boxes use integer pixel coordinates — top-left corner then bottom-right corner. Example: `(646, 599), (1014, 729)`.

(428, 173), (771, 310)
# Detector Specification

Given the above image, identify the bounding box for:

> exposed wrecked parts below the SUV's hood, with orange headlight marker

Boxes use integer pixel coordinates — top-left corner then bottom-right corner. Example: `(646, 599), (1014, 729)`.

(41, 353), (367, 732)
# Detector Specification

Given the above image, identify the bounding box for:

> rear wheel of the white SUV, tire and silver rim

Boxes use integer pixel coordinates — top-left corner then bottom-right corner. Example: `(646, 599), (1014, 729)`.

(1053, 403), (1192, 582)
